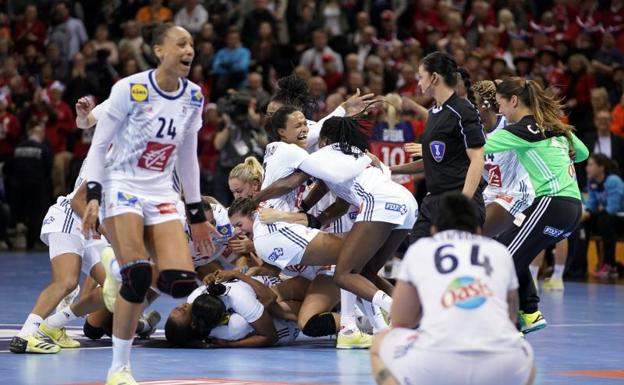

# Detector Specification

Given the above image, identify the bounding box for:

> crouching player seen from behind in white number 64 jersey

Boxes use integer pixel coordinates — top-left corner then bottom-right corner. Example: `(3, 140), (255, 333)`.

(371, 192), (534, 385)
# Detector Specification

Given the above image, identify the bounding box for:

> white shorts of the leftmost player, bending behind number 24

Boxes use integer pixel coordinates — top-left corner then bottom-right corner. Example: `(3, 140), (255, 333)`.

(39, 197), (84, 243)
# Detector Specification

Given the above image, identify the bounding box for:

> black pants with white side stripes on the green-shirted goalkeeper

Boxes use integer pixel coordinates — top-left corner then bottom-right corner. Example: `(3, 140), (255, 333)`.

(496, 197), (582, 313)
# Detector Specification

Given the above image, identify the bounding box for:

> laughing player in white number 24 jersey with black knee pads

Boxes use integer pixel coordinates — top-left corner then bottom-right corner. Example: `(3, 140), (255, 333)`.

(83, 24), (215, 385)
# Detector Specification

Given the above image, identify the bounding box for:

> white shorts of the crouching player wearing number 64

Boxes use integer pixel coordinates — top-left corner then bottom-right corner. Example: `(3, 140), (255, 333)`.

(379, 328), (533, 385)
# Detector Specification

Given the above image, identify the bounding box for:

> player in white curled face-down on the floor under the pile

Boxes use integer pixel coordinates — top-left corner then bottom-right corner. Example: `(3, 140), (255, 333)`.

(165, 271), (284, 347)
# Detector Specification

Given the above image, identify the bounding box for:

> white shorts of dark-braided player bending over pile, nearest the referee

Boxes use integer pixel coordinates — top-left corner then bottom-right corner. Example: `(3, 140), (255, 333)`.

(355, 181), (418, 230)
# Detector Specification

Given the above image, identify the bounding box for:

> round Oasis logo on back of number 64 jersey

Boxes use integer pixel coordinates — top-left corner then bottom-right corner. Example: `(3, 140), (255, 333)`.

(442, 276), (493, 309)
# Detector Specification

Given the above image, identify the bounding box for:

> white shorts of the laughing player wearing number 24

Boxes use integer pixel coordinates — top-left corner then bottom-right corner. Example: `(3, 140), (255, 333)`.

(102, 186), (182, 226)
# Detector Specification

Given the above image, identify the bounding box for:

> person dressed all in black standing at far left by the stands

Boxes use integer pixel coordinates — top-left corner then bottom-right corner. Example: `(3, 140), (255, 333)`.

(9, 121), (52, 248)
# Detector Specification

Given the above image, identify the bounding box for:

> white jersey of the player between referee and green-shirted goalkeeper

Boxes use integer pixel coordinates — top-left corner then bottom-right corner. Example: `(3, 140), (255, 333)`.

(483, 115), (535, 215)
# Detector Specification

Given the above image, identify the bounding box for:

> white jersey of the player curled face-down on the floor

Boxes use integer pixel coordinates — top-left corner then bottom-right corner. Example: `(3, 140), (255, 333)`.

(186, 280), (264, 323)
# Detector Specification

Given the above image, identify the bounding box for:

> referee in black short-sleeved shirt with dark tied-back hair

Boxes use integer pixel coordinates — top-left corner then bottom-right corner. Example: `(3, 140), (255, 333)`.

(392, 52), (486, 243)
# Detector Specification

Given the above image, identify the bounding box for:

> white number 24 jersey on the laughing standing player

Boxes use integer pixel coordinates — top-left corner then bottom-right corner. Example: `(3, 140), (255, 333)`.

(88, 70), (203, 200)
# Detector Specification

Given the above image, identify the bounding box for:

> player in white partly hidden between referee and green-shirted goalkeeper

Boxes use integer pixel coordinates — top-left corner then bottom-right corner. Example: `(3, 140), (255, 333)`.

(472, 80), (535, 237)
